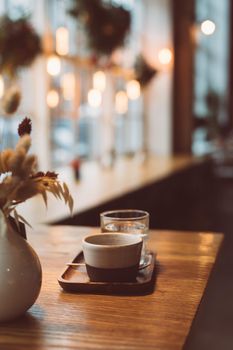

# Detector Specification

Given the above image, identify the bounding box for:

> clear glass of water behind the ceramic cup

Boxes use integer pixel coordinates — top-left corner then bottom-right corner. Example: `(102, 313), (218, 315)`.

(100, 209), (150, 265)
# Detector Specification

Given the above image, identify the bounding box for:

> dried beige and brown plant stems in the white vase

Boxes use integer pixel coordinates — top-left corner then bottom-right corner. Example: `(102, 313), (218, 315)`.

(0, 118), (73, 233)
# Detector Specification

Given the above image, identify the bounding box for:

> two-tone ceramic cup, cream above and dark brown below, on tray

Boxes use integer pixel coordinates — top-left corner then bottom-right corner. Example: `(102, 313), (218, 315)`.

(82, 233), (142, 282)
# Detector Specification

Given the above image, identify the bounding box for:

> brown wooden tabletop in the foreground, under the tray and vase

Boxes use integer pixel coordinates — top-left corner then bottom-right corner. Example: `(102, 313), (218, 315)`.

(0, 226), (223, 350)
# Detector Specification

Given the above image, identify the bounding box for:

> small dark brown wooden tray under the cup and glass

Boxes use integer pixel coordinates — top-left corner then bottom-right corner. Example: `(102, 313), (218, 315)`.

(58, 252), (158, 295)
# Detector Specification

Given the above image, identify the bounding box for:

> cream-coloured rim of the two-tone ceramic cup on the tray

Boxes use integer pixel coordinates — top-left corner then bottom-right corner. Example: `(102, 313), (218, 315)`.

(82, 232), (142, 249)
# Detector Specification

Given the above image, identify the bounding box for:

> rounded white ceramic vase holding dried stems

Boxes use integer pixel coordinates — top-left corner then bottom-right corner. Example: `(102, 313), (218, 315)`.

(0, 213), (42, 322)
